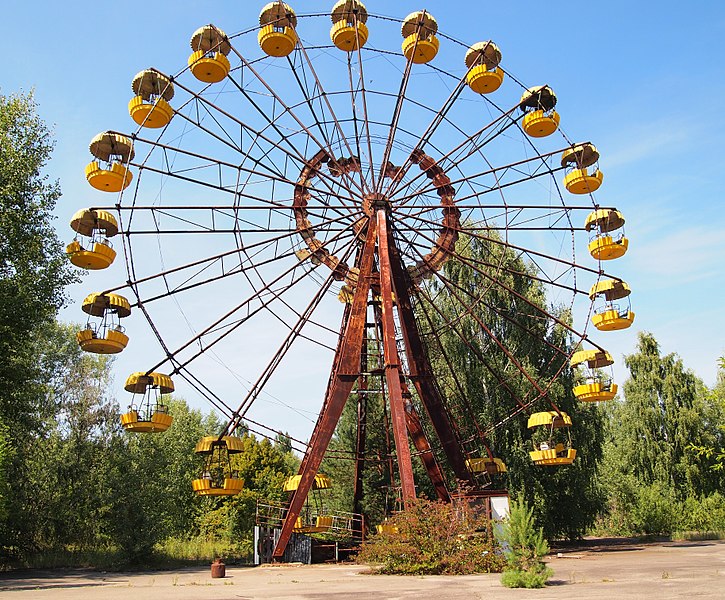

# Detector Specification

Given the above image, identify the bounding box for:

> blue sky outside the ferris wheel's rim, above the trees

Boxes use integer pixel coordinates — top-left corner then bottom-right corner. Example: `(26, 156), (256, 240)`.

(0, 0), (725, 437)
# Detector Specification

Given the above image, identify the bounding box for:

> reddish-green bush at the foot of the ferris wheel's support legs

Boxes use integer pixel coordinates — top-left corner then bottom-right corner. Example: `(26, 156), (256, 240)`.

(357, 498), (504, 575)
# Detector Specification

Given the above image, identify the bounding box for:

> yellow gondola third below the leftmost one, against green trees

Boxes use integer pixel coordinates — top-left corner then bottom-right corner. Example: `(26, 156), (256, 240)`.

(192, 435), (244, 496)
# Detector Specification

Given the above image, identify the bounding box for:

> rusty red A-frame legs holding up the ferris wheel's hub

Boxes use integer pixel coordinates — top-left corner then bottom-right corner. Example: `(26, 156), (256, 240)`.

(273, 204), (470, 560)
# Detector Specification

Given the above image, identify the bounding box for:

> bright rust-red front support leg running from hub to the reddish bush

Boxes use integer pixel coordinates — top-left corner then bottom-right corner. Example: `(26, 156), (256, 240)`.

(375, 206), (416, 508)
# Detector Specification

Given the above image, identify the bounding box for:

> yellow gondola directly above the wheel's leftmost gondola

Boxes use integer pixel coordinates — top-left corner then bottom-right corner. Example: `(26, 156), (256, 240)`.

(86, 131), (134, 192)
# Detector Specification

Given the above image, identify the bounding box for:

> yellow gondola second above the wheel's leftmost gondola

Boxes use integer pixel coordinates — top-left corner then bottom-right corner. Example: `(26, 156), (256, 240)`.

(128, 69), (174, 129)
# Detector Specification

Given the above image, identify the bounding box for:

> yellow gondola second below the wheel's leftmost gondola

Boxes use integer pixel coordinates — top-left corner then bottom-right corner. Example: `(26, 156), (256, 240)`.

(121, 372), (174, 433)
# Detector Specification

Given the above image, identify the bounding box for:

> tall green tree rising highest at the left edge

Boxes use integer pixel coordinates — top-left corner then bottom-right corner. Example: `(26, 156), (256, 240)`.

(0, 94), (74, 548)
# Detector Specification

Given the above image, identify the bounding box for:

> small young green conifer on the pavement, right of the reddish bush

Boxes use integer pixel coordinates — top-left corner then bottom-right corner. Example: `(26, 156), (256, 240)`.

(500, 501), (552, 588)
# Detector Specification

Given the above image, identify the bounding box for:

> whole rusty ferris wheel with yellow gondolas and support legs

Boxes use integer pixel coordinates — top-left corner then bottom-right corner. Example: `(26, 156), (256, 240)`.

(68, 0), (634, 556)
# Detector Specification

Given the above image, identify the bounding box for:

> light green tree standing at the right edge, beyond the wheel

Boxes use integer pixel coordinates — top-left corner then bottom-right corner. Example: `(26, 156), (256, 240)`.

(603, 332), (723, 533)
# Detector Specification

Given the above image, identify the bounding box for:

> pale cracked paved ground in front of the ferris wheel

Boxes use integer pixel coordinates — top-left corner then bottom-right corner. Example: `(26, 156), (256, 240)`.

(0, 542), (725, 600)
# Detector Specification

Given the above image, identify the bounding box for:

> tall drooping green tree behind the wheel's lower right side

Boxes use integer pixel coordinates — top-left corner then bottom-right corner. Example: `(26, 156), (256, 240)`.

(421, 233), (604, 538)
